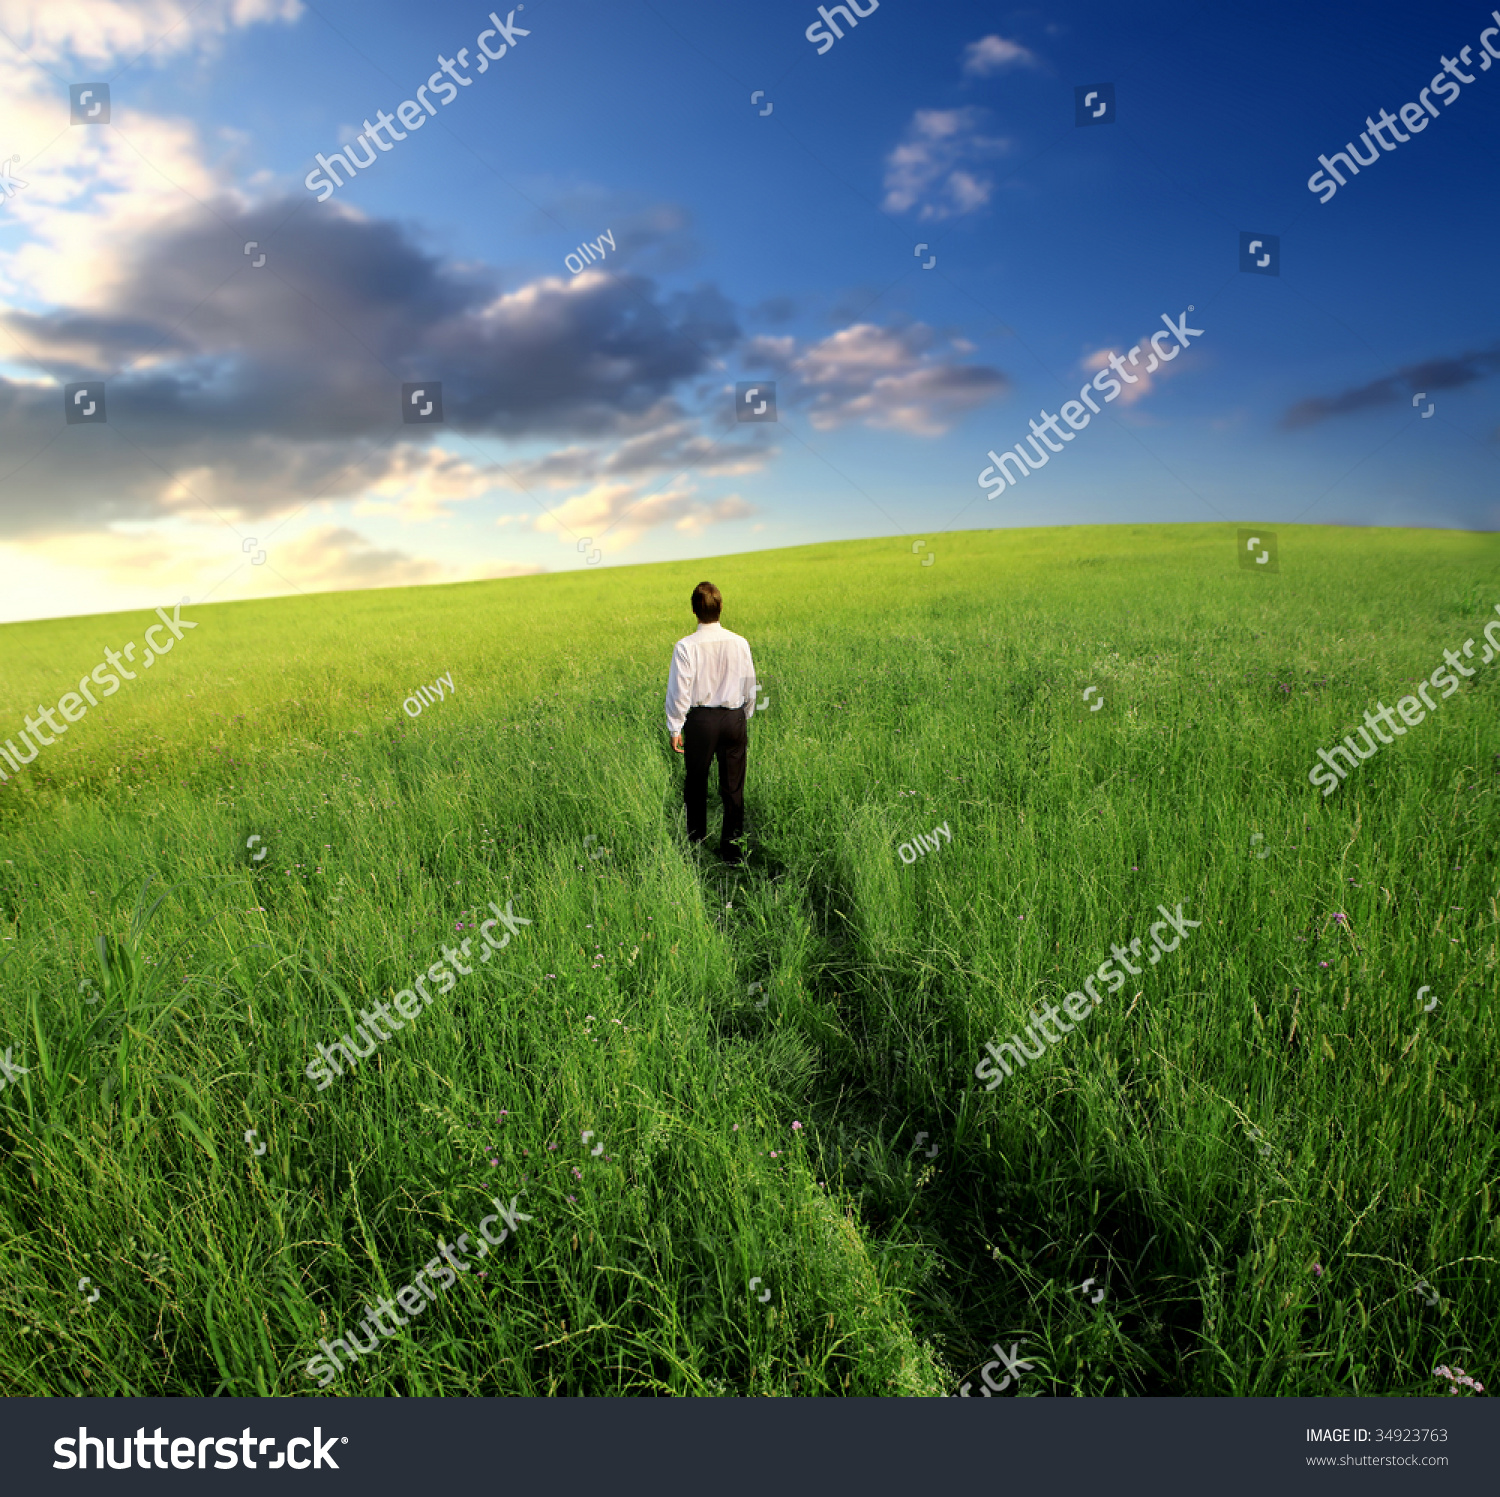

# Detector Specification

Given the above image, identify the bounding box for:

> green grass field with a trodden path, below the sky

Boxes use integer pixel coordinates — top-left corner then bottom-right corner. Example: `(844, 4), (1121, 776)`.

(0, 525), (1500, 1397)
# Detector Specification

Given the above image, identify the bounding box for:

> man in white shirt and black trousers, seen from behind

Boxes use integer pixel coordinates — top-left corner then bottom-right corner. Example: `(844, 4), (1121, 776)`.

(666, 582), (755, 863)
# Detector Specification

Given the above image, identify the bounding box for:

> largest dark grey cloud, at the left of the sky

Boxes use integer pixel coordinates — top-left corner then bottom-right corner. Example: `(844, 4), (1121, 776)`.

(0, 200), (740, 536)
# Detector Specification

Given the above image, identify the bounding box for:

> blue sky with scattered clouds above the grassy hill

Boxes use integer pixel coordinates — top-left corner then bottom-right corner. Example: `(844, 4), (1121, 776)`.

(0, 0), (1500, 620)
